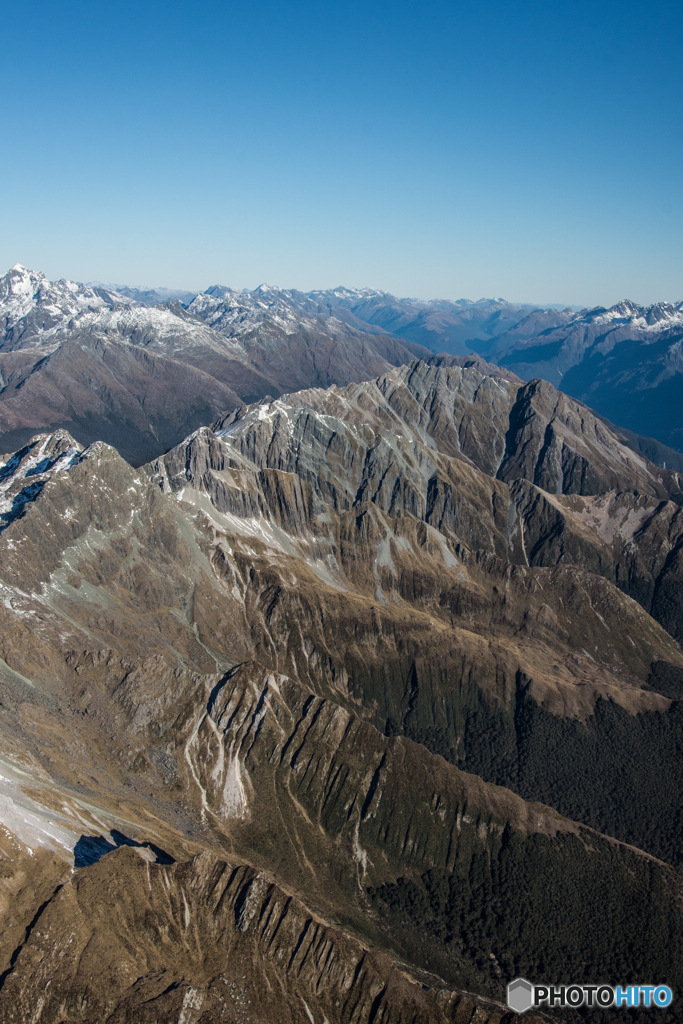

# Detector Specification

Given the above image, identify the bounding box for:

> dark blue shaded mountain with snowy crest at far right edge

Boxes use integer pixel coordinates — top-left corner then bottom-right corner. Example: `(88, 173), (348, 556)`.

(488, 302), (683, 454)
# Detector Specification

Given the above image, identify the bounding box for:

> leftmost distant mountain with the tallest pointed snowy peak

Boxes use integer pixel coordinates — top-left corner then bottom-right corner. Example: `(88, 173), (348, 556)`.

(0, 266), (270, 464)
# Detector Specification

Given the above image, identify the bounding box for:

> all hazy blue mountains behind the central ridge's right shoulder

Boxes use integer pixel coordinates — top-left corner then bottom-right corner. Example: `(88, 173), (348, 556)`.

(286, 289), (683, 462)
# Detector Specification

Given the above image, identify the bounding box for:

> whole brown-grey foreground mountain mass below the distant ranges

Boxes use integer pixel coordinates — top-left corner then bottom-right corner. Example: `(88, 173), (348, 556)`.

(0, 362), (683, 1024)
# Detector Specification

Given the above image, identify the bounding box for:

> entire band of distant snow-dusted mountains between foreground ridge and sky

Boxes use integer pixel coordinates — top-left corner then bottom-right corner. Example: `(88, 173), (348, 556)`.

(0, 264), (683, 469)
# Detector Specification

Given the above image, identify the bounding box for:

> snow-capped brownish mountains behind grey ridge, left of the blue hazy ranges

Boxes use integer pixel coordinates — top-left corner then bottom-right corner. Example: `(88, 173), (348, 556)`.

(0, 264), (422, 465)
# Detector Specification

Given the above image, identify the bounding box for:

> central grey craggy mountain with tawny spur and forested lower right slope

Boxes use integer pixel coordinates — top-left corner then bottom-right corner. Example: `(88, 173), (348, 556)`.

(152, 364), (683, 862)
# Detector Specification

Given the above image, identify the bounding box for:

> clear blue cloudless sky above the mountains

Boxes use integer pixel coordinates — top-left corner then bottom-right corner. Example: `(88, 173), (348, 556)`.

(0, 0), (683, 305)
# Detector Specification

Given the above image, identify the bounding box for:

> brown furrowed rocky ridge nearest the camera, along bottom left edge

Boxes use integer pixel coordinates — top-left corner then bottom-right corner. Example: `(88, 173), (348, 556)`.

(0, 847), (524, 1024)
